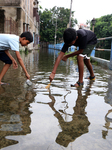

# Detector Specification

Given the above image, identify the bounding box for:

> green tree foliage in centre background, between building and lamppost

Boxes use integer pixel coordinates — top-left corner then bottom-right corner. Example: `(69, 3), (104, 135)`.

(39, 6), (77, 42)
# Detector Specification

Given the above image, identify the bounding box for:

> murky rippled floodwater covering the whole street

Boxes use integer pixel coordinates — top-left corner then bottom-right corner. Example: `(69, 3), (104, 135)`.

(0, 49), (112, 150)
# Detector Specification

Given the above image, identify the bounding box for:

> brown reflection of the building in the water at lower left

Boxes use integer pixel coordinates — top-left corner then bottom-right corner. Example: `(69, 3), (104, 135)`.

(0, 86), (35, 148)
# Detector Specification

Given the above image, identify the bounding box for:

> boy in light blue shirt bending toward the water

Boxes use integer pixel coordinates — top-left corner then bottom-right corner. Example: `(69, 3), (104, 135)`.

(0, 32), (33, 85)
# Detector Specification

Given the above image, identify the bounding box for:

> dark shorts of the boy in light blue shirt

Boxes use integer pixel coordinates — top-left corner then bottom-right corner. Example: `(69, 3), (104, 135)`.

(0, 51), (12, 64)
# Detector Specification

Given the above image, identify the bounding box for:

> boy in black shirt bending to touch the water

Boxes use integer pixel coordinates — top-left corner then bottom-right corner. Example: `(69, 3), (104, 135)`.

(49, 28), (97, 87)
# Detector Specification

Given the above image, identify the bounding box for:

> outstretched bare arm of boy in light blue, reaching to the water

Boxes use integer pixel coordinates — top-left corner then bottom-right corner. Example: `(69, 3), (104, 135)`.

(16, 51), (30, 79)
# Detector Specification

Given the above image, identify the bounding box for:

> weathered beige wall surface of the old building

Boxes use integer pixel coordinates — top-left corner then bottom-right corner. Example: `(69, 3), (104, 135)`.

(0, 0), (39, 49)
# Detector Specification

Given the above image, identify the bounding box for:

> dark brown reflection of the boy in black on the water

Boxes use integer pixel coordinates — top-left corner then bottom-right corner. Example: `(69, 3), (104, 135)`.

(37, 81), (93, 147)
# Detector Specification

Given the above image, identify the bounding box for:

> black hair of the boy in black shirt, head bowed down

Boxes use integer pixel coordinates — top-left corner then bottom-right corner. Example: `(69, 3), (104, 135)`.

(63, 28), (77, 44)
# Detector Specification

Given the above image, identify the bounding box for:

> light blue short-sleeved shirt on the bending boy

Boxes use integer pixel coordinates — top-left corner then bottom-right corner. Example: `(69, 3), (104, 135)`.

(0, 34), (19, 51)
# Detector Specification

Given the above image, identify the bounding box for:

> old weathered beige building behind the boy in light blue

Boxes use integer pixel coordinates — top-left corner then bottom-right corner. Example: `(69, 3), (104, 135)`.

(0, 0), (39, 49)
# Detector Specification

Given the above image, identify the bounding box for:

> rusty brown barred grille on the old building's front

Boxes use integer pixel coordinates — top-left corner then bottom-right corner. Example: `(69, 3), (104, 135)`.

(4, 18), (18, 35)
